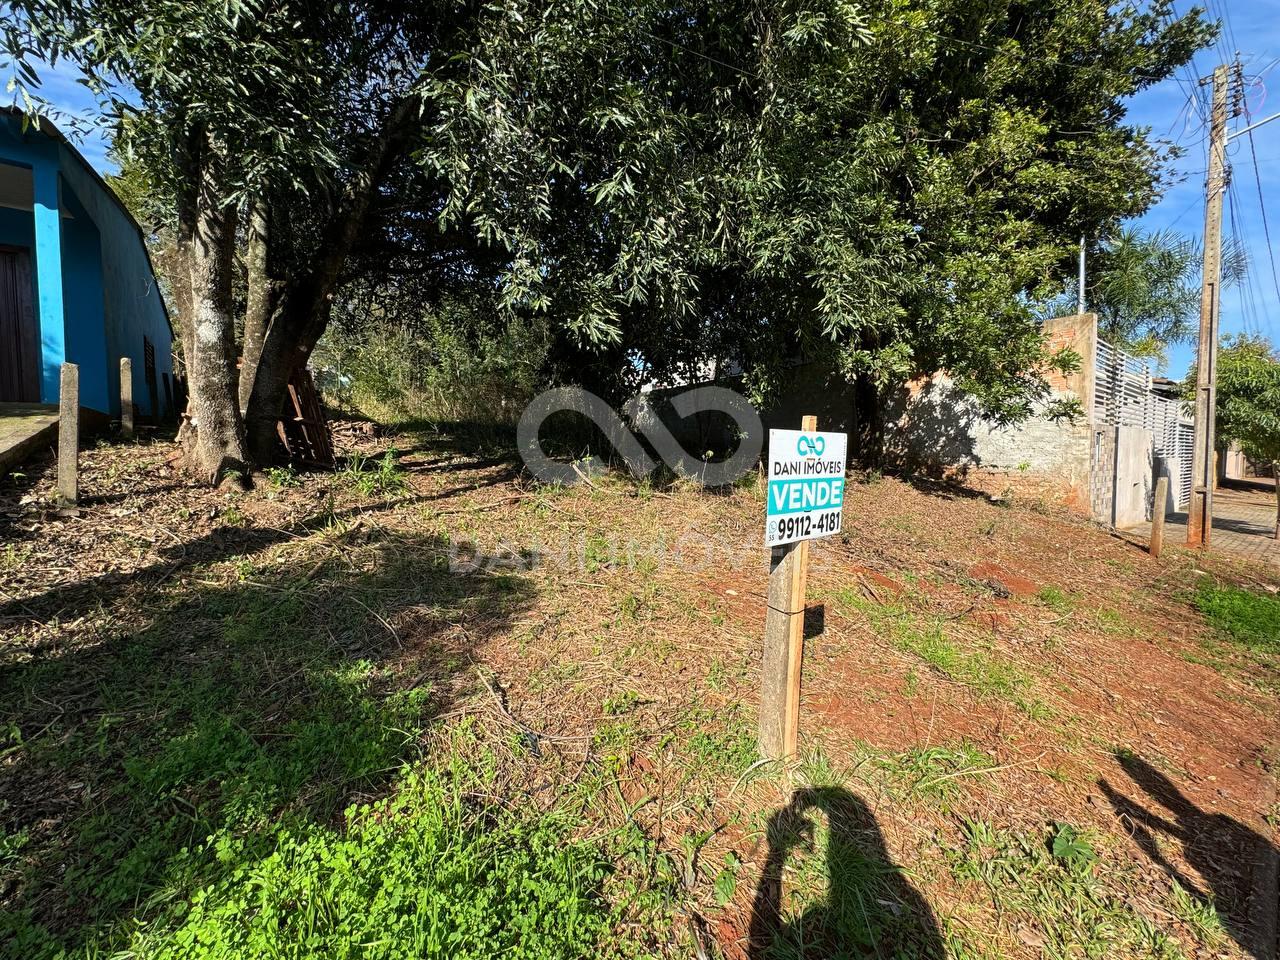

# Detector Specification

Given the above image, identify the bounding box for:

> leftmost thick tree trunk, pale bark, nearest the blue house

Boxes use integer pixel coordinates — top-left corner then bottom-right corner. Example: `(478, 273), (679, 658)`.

(187, 140), (248, 485)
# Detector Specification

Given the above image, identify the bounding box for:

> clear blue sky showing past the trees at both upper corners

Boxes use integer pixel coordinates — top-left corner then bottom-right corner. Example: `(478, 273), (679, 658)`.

(20, 0), (1280, 378)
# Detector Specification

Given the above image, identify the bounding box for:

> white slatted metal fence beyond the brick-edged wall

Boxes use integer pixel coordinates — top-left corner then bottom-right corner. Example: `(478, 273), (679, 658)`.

(1093, 340), (1194, 509)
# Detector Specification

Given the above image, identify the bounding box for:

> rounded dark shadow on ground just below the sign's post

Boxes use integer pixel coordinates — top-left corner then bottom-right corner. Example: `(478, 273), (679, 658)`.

(749, 787), (943, 960)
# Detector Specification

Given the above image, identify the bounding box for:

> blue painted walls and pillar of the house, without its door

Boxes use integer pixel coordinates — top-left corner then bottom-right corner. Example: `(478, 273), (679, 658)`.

(0, 115), (173, 415)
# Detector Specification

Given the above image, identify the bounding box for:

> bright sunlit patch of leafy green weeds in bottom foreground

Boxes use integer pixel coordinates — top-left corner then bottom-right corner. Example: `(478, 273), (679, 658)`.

(140, 768), (608, 960)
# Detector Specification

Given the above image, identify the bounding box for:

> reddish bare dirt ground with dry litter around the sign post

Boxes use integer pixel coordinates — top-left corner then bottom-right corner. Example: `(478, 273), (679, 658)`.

(0, 435), (1280, 957)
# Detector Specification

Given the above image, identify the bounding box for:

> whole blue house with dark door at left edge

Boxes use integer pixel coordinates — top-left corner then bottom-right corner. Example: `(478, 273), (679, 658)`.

(0, 110), (174, 417)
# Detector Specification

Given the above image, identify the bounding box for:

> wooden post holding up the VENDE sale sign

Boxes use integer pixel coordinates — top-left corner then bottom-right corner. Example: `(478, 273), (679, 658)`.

(759, 416), (818, 760)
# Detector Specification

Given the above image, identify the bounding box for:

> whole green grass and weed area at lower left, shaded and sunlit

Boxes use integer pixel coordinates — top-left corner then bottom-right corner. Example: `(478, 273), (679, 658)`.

(0, 538), (671, 960)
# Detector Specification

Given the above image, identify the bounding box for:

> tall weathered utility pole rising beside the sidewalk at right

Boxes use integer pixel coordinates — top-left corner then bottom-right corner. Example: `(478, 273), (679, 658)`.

(1187, 65), (1228, 547)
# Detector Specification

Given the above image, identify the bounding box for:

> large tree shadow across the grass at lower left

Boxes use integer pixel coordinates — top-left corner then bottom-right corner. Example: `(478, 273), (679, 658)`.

(0, 529), (532, 957)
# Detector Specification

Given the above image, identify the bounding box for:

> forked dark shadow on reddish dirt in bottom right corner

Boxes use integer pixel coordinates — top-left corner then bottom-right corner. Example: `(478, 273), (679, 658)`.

(1098, 754), (1276, 960)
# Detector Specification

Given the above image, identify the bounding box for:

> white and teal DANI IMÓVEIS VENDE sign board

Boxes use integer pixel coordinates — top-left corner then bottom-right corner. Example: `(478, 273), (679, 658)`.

(764, 430), (849, 547)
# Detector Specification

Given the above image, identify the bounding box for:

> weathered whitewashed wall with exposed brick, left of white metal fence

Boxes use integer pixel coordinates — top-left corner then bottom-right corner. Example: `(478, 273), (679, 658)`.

(884, 314), (1096, 513)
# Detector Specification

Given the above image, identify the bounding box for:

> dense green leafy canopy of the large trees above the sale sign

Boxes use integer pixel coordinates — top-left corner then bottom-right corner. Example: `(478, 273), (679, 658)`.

(426, 0), (1212, 419)
